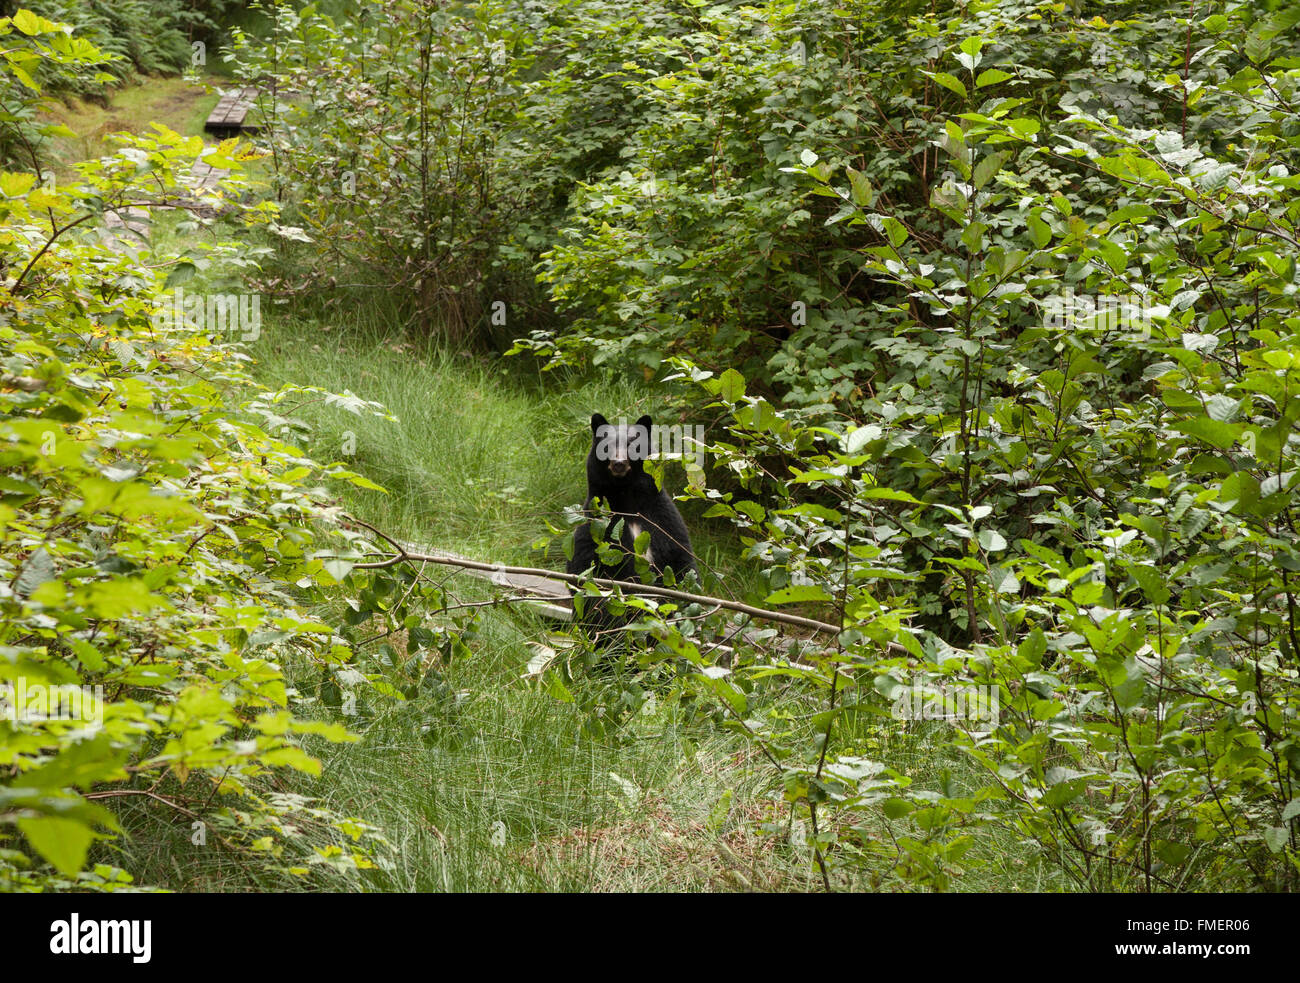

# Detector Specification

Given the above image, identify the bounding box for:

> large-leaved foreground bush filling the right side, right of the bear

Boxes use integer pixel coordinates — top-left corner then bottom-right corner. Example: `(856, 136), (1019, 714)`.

(639, 0), (1300, 891)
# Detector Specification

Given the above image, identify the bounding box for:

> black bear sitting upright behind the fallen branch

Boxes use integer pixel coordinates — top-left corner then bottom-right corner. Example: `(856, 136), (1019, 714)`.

(566, 413), (696, 642)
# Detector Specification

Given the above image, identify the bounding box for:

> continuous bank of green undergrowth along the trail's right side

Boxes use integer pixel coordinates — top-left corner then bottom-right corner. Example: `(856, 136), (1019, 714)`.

(226, 0), (1300, 891)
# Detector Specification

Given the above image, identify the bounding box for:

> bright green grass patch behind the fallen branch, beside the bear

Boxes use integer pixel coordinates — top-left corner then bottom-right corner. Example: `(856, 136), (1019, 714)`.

(252, 306), (749, 579)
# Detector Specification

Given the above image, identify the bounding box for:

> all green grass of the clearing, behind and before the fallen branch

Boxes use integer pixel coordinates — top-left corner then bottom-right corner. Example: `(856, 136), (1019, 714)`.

(178, 304), (1044, 891)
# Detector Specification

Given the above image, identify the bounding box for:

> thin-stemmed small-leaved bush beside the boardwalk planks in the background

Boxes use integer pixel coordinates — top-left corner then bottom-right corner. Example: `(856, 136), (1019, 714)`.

(226, 0), (546, 343)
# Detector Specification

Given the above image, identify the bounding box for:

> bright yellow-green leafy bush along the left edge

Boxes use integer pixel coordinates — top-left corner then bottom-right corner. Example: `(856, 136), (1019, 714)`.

(0, 12), (392, 889)
